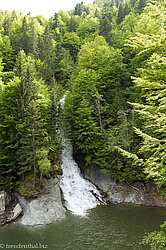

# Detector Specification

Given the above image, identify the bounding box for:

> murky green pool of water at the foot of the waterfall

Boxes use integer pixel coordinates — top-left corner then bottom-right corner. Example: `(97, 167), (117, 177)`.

(0, 205), (166, 250)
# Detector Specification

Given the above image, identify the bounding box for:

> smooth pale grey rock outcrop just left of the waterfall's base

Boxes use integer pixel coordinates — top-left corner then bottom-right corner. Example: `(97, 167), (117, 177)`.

(20, 179), (65, 226)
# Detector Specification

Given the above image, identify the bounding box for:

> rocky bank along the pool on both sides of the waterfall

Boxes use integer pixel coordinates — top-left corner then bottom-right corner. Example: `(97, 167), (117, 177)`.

(0, 167), (166, 226)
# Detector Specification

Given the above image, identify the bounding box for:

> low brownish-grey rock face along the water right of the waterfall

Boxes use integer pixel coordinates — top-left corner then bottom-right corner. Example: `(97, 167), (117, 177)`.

(83, 167), (166, 207)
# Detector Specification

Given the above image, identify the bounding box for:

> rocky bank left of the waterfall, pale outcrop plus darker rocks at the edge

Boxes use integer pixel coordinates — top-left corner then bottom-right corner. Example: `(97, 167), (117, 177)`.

(0, 178), (66, 226)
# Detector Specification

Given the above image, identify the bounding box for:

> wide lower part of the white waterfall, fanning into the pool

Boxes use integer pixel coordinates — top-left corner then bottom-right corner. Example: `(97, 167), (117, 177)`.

(60, 139), (102, 216)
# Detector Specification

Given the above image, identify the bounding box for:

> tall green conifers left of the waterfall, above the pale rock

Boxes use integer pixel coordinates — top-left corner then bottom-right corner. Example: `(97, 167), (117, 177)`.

(0, 51), (61, 188)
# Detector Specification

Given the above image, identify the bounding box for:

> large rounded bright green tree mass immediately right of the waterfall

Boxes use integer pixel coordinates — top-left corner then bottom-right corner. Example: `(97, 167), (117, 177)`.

(65, 36), (132, 180)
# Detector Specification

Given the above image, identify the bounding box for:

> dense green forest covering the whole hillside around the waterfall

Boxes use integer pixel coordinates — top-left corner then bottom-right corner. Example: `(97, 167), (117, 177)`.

(0, 0), (166, 246)
